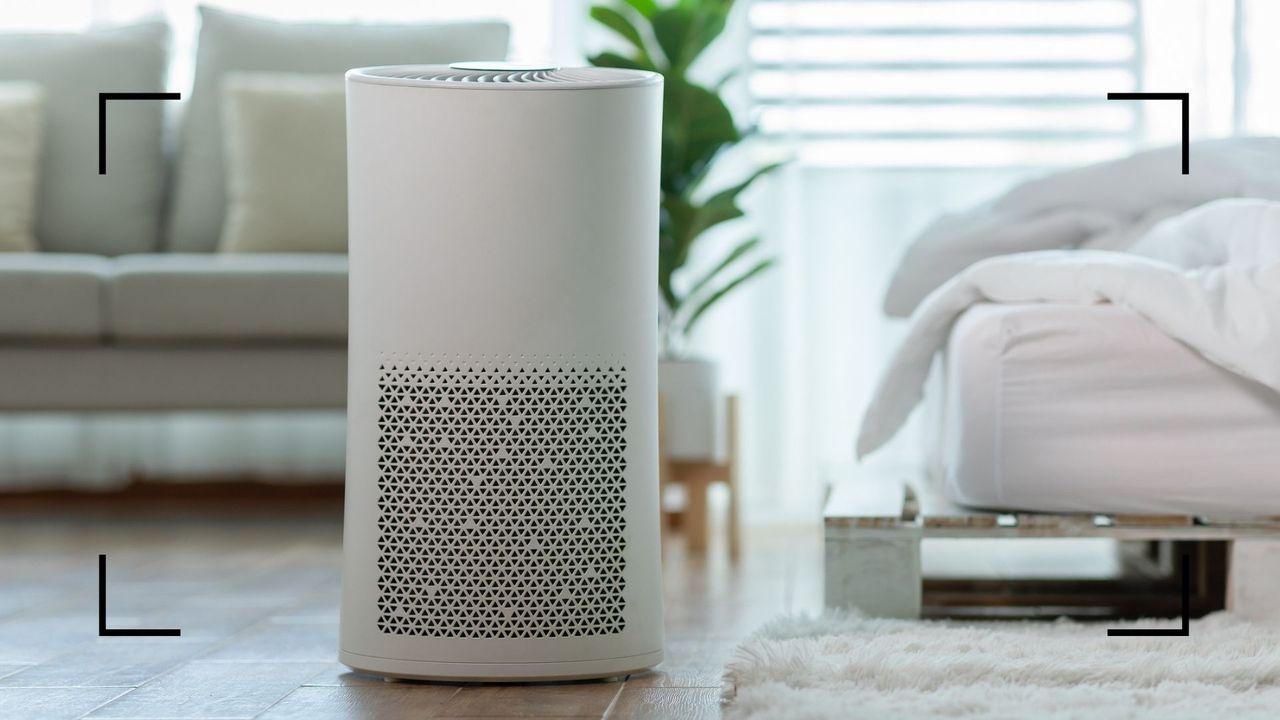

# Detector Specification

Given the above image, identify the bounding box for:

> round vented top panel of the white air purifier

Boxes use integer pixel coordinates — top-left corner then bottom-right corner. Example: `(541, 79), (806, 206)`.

(347, 61), (662, 90)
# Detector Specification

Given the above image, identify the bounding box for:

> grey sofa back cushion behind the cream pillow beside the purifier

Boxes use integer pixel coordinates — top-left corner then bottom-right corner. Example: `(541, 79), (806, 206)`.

(169, 6), (507, 252)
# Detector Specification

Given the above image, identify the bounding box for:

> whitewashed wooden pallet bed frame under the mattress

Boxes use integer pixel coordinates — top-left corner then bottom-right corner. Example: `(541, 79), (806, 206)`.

(823, 477), (1280, 619)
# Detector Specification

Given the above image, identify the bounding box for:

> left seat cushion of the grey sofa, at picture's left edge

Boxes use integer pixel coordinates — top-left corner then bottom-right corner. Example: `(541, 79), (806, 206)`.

(0, 252), (110, 343)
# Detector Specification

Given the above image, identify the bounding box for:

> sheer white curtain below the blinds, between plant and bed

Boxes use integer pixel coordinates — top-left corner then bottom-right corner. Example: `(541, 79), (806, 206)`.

(694, 167), (1029, 524)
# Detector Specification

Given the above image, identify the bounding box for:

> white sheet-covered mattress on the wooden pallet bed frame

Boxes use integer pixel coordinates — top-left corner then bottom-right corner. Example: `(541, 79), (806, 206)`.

(934, 305), (1280, 516)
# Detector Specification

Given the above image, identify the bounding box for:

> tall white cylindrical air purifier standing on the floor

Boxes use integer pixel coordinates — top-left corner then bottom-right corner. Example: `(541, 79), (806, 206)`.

(340, 63), (663, 680)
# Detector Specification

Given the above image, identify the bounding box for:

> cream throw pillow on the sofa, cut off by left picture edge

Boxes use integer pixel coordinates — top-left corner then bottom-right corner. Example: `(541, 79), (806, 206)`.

(0, 82), (44, 252)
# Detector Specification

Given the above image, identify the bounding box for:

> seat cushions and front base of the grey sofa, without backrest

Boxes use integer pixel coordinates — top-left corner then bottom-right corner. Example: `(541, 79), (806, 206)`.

(0, 252), (347, 411)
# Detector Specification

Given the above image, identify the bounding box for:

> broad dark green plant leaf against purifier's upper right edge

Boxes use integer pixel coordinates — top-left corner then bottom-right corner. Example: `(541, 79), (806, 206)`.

(662, 76), (740, 195)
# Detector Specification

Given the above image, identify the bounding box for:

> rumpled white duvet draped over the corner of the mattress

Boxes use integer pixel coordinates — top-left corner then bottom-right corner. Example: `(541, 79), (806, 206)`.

(858, 196), (1280, 456)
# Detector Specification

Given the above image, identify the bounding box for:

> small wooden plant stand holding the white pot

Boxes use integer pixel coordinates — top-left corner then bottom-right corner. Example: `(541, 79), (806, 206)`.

(658, 395), (741, 559)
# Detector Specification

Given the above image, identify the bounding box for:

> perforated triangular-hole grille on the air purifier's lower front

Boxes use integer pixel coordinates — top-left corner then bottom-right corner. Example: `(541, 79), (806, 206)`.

(378, 363), (627, 638)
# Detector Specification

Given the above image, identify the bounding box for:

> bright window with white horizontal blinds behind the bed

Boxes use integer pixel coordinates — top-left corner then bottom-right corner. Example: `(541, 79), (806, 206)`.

(749, 0), (1148, 167)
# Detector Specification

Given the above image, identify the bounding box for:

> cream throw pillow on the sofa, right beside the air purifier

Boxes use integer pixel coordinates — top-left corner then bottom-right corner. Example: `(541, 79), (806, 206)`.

(219, 73), (347, 252)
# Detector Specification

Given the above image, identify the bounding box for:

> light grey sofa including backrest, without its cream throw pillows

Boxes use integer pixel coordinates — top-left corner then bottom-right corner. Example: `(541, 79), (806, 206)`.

(0, 8), (507, 411)
